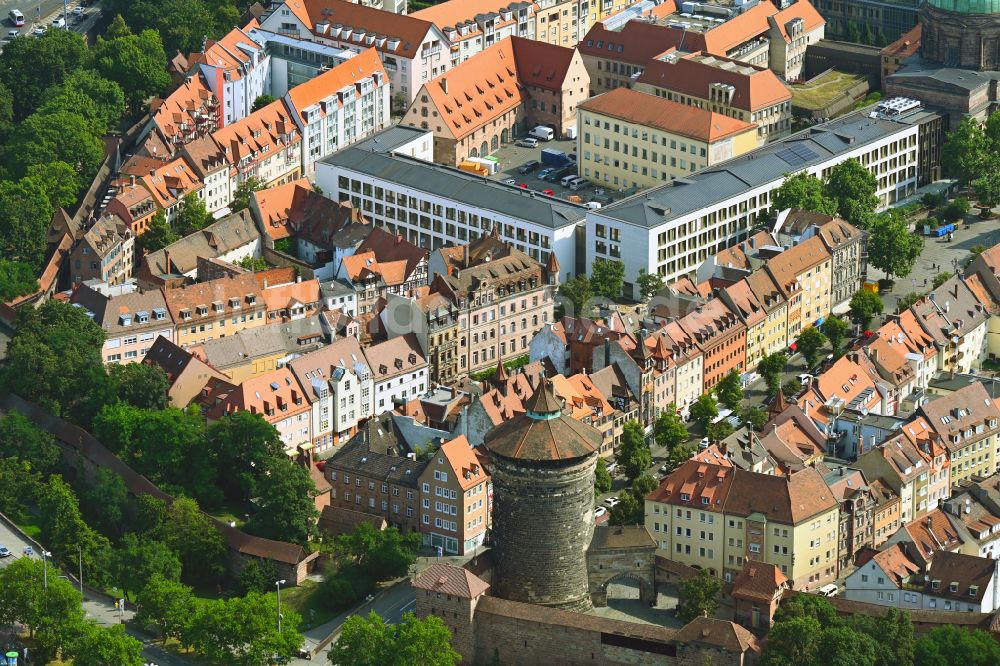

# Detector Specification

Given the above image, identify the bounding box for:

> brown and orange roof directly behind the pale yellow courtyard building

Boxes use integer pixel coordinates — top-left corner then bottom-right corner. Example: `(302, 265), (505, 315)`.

(636, 53), (792, 112)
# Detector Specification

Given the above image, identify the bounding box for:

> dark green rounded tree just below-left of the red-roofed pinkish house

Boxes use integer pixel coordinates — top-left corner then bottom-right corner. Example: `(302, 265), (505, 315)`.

(205, 412), (287, 502)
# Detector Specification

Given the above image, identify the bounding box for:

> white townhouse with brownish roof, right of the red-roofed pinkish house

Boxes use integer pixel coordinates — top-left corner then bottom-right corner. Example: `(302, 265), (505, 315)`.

(288, 337), (375, 454)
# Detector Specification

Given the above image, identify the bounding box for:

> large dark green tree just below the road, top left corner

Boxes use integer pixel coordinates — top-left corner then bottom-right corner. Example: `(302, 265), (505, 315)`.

(0, 30), (89, 121)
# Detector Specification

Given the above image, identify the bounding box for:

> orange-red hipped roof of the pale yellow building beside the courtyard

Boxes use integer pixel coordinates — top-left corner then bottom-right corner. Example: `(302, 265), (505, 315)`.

(577, 88), (756, 143)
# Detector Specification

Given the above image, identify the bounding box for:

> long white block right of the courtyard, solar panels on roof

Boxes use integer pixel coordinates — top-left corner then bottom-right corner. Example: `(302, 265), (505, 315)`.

(584, 104), (937, 297)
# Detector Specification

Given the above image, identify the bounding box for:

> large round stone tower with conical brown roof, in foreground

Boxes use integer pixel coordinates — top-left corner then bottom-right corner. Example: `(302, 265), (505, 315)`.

(484, 380), (602, 611)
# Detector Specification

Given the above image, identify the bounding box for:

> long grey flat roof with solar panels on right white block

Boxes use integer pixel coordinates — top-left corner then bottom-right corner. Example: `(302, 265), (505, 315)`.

(598, 109), (926, 228)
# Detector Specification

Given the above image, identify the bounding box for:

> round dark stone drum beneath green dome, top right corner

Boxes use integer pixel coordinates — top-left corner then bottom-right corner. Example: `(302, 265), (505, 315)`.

(920, 0), (1000, 71)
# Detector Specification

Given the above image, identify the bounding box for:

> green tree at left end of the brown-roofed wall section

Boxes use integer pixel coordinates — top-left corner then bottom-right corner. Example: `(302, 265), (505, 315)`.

(158, 497), (226, 583)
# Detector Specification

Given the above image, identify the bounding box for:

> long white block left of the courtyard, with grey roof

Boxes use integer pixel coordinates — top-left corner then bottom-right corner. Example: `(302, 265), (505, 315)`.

(316, 126), (587, 279)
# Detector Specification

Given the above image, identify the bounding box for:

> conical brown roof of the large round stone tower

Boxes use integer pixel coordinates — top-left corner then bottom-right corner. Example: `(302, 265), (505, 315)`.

(483, 379), (604, 461)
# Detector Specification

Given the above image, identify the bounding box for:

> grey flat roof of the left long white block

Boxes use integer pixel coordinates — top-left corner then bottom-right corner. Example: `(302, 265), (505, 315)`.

(320, 126), (587, 229)
